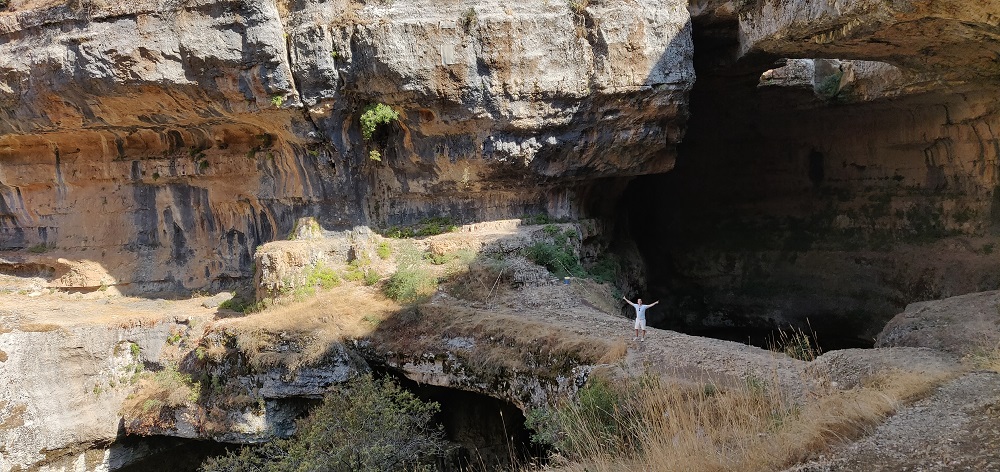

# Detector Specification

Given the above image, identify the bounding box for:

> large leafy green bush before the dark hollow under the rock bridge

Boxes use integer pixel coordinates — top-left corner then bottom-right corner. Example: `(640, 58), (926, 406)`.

(201, 376), (449, 472)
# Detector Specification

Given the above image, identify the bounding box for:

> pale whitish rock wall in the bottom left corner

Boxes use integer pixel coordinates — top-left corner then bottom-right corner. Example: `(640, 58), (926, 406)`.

(0, 304), (191, 470)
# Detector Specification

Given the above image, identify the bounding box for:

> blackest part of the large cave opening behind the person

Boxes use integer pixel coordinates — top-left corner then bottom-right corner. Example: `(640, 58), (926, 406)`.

(616, 9), (896, 351)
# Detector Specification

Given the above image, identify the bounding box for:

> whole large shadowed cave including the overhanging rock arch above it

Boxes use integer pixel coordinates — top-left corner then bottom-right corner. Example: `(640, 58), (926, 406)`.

(623, 0), (1000, 340)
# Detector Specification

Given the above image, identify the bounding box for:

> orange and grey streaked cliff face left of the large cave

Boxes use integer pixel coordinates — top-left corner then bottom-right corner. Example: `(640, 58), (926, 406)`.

(0, 0), (694, 292)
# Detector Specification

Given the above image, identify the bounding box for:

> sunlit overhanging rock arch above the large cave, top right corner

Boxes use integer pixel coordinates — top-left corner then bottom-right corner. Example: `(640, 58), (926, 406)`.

(739, 0), (1000, 78)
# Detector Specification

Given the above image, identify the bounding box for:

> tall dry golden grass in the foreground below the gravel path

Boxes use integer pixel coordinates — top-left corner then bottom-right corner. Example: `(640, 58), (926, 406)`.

(540, 372), (954, 472)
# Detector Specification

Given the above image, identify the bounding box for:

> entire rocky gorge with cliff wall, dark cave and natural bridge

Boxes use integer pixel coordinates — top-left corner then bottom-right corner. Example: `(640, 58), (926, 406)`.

(0, 0), (1000, 471)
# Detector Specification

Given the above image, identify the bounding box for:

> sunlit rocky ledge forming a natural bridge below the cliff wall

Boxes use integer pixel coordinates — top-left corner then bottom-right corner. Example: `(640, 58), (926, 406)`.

(0, 223), (822, 471)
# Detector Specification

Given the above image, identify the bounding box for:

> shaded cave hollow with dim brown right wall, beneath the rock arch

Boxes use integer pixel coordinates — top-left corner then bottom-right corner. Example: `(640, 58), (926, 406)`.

(618, 3), (1000, 348)
